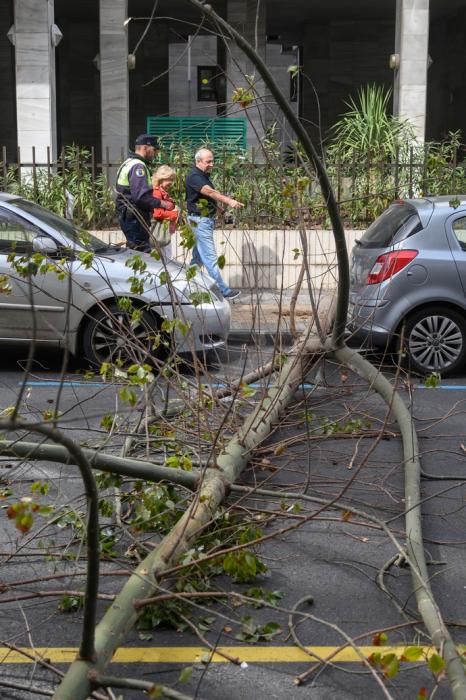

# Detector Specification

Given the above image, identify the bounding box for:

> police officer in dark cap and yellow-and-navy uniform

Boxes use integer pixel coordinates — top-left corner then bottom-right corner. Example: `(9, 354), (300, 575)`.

(116, 134), (173, 252)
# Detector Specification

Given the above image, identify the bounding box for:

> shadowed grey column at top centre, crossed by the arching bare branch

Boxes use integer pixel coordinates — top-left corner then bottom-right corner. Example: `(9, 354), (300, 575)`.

(226, 0), (266, 153)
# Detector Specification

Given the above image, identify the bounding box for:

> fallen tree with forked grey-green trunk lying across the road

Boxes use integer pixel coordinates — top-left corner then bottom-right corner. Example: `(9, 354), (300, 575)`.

(0, 0), (466, 700)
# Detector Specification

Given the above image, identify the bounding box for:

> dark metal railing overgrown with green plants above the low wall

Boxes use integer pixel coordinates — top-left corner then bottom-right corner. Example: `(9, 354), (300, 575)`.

(0, 144), (466, 228)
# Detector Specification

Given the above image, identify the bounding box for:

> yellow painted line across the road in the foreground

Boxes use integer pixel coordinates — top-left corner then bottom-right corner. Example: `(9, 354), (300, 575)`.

(0, 645), (448, 664)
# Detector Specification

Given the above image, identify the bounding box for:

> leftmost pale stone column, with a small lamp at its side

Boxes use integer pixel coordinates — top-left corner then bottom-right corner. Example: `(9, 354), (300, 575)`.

(13, 0), (61, 163)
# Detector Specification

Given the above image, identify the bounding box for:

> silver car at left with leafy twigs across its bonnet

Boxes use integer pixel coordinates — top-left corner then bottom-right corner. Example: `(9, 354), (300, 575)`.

(0, 193), (230, 366)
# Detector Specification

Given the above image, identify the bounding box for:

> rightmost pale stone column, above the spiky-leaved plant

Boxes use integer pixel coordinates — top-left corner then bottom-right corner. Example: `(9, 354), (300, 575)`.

(392, 0), (429, 141)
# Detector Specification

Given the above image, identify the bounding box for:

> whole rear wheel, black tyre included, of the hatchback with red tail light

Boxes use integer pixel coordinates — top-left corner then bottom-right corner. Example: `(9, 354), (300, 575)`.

(404, 306), (466, 376)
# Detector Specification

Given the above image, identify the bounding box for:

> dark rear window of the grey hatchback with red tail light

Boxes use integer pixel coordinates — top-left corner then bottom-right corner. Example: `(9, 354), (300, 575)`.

(359, 204), (422, 248)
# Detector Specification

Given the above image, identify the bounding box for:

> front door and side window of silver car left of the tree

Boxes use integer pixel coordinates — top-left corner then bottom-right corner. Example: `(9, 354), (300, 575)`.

(0, 209), (66, 342)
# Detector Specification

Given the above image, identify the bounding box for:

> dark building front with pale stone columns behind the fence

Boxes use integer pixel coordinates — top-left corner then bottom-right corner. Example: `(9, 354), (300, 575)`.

(0, 0), (466, 162)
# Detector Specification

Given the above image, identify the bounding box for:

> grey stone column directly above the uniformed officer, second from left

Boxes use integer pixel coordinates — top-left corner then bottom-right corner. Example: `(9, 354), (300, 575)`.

(100, 0), (128, 162)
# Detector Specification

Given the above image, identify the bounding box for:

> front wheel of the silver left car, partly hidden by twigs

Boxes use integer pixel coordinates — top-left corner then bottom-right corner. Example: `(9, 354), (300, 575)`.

(82, 303), (169, 367)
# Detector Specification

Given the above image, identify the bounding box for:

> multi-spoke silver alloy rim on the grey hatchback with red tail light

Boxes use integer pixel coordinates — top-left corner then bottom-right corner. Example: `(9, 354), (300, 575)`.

(408, 315), (463, 371)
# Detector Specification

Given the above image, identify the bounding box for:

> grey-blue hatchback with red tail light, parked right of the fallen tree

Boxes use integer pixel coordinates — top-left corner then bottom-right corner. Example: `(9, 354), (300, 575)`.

(348, 196), (466, 375)
